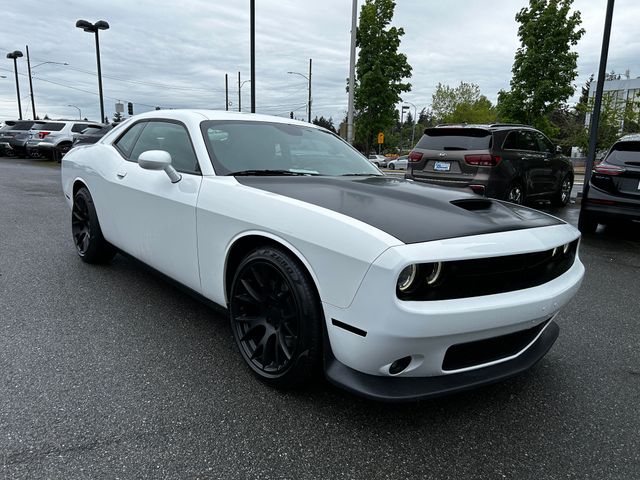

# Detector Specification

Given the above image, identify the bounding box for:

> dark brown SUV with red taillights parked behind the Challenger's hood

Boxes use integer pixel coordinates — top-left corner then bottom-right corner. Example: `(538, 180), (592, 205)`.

(406, 124), (574, 206)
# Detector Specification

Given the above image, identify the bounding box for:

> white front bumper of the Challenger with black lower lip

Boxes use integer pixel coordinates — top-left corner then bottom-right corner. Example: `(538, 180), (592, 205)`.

(323, 224), (584, 400)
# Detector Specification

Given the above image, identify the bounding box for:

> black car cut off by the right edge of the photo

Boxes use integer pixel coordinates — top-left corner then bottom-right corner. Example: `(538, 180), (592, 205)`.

(578, 135), (640, 233)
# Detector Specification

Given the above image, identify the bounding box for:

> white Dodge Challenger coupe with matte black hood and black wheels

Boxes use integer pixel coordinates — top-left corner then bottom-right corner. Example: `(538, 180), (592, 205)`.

(62, 110), (584, 401)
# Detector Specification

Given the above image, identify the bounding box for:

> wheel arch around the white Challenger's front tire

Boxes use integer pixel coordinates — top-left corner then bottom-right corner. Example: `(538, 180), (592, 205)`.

(223, 231), (322, 305)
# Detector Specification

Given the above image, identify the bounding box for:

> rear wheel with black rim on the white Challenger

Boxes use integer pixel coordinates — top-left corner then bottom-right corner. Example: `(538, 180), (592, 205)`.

(71, 187), (116, 263)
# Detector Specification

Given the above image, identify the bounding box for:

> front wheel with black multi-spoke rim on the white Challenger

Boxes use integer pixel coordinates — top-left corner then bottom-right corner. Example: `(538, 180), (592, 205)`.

(229, 247), (323, 388)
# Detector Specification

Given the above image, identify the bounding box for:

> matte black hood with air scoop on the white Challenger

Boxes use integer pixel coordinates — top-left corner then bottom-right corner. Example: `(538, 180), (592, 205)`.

(236, 176), (563, 243)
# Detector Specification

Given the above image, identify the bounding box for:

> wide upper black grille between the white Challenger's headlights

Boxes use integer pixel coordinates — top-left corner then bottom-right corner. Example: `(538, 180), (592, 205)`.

(396, 239), (578, 300)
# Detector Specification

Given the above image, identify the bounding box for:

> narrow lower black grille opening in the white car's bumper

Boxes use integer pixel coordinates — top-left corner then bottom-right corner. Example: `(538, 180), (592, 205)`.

(442, 320), (549, 371)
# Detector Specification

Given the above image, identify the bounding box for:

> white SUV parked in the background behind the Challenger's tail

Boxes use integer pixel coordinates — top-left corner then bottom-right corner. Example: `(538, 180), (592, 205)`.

(26, 120), (104, 159)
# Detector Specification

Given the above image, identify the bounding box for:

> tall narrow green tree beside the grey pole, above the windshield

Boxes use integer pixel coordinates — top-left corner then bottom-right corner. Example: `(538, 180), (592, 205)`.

(354, 0), (411, 152)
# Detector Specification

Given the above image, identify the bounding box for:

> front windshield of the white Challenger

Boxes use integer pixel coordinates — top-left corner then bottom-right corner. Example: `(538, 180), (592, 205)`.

(201, 120), (381, 176)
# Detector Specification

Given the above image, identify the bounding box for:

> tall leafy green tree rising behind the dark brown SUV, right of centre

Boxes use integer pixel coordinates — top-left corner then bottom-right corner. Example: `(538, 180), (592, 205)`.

(498, 0), (584, 136)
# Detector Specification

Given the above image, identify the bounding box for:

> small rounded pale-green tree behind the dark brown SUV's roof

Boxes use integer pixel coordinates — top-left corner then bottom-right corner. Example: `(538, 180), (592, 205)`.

(431, 82), (497, 123)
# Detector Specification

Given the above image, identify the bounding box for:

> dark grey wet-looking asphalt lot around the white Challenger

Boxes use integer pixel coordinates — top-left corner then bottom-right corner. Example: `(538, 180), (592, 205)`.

(0, 158), (640, 479)
